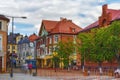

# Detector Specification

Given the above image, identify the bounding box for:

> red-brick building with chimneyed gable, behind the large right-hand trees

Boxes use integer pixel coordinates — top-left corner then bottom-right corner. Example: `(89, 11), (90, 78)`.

(80, 4), (120, 67)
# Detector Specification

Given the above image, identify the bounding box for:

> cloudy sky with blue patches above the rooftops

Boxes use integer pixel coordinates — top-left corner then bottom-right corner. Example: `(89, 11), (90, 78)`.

(0, 0), (120, 35)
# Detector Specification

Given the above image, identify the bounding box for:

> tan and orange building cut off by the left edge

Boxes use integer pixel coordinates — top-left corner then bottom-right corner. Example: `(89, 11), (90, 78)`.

(0, 15), (9, 73)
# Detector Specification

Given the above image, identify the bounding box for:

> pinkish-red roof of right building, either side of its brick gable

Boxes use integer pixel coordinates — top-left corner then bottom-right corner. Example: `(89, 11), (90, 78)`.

(81, 9), (120, 32)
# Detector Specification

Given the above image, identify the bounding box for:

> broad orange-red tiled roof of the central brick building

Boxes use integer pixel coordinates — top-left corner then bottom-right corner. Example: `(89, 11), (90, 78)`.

(43, 19), (82, 34)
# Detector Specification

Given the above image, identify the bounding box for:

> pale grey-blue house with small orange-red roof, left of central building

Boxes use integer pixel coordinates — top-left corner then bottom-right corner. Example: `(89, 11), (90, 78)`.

(18, 33), (38, 63)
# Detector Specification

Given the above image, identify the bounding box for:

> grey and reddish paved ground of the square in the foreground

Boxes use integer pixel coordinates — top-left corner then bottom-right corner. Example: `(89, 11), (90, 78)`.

(0, 69), (120, 80)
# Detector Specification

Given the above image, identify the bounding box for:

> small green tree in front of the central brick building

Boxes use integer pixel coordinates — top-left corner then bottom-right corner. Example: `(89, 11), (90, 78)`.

(56, 41), (74, 67)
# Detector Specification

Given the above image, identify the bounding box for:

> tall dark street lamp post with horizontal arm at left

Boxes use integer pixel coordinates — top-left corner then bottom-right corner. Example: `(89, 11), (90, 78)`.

(6, 16), (27, 77)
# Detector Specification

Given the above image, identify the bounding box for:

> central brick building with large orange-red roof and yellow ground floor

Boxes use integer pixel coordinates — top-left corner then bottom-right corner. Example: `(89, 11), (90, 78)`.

(37, 18), (81, 68)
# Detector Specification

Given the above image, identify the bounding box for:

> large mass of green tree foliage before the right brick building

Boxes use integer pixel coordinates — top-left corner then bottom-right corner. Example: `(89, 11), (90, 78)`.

(78, 21), (120, 70)
